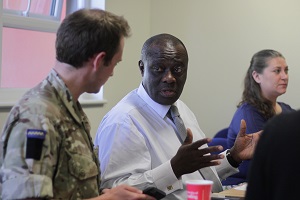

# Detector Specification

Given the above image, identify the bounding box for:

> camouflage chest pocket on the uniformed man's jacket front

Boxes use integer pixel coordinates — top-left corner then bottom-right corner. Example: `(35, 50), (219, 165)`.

(68, 154), (99, 180)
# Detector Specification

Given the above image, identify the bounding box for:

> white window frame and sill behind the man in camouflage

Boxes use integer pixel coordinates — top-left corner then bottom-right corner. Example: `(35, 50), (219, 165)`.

(0, 0), (107, 108)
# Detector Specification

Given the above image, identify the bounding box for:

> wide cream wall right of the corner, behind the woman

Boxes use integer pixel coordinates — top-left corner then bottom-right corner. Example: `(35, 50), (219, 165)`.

(151, 0), (300, 136)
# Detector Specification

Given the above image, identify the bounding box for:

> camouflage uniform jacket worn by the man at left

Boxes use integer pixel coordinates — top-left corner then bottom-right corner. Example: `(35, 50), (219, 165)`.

(0, 70), (100, 199)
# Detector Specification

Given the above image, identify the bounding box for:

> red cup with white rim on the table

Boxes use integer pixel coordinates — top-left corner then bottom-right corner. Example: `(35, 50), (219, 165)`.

(186, 180), (213, 200)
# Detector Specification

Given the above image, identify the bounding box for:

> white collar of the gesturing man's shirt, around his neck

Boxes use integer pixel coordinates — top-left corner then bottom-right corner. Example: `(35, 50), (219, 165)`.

(137, 83), (176, 118)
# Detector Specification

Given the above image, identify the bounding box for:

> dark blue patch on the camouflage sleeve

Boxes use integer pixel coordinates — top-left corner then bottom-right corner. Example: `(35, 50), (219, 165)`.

(26, 129), (47, 160)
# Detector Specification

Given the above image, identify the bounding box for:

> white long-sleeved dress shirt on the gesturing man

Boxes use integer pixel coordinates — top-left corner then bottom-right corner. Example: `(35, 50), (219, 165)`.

(95, 84), (238, 199)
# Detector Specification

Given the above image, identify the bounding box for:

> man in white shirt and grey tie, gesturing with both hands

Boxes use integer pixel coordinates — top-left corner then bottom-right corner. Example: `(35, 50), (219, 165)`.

(95, 34), (259, 199)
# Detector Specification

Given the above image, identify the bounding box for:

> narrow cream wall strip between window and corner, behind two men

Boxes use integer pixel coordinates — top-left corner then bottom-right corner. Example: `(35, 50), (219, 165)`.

(84, 0), (150, 139)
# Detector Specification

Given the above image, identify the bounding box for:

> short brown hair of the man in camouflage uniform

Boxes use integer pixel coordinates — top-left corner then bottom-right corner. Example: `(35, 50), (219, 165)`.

(55, 9), (130, 68)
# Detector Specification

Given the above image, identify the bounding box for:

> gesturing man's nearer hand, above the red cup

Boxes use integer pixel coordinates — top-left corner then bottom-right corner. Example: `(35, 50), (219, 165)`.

(171, 128), (224, 178)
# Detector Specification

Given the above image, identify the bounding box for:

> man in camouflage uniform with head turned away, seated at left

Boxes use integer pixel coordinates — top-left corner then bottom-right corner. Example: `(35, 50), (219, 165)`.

(0, 9), (152, 200)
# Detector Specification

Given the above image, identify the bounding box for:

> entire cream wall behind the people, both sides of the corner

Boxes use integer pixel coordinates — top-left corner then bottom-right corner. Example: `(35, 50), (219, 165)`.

(0, 0), (300, 137)
